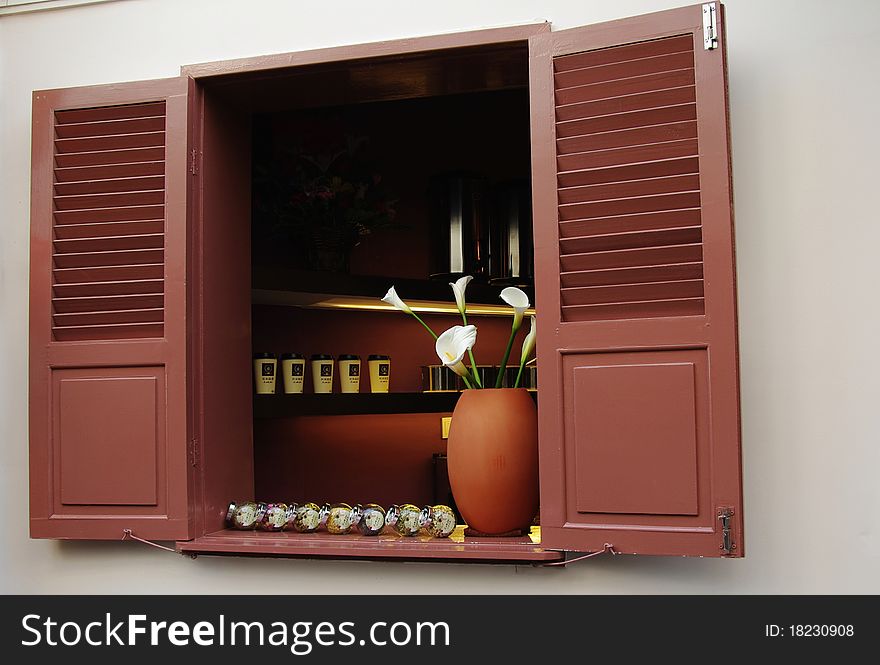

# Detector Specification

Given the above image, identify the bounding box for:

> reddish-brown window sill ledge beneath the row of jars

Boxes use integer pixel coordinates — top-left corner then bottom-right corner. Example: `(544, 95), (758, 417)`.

(177, 527), (564, 563)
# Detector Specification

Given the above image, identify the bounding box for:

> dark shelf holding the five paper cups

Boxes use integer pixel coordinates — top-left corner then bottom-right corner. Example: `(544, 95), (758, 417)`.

(254, 392), (461, 418)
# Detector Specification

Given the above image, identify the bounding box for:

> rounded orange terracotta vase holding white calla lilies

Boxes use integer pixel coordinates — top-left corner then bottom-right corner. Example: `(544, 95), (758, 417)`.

(447, 388), (538, 534)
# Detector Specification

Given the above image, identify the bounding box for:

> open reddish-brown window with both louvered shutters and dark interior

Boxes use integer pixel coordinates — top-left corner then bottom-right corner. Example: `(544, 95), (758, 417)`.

(31, 6), (742, 563)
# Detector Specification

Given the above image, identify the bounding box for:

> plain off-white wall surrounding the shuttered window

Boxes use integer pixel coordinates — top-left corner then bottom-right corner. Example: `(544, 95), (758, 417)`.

(0, 0), (880, 593)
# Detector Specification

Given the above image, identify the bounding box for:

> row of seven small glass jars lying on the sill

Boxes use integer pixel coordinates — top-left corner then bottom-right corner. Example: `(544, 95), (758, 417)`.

(226, 501), (456, 538)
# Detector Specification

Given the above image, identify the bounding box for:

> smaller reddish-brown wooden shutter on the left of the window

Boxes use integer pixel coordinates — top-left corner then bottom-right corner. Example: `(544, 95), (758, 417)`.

(30, 78), (191, 539)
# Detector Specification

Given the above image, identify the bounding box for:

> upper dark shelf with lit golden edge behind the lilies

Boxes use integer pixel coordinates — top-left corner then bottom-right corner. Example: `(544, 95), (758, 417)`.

(251, 265), (534, 316)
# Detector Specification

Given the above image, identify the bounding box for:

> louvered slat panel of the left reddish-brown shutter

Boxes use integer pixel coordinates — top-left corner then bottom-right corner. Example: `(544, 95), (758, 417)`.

(52, 100), (165, 341)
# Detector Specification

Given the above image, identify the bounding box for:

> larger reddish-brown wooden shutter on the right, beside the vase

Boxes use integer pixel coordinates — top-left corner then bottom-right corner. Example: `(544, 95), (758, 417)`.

(530, 5), (743, 556)
